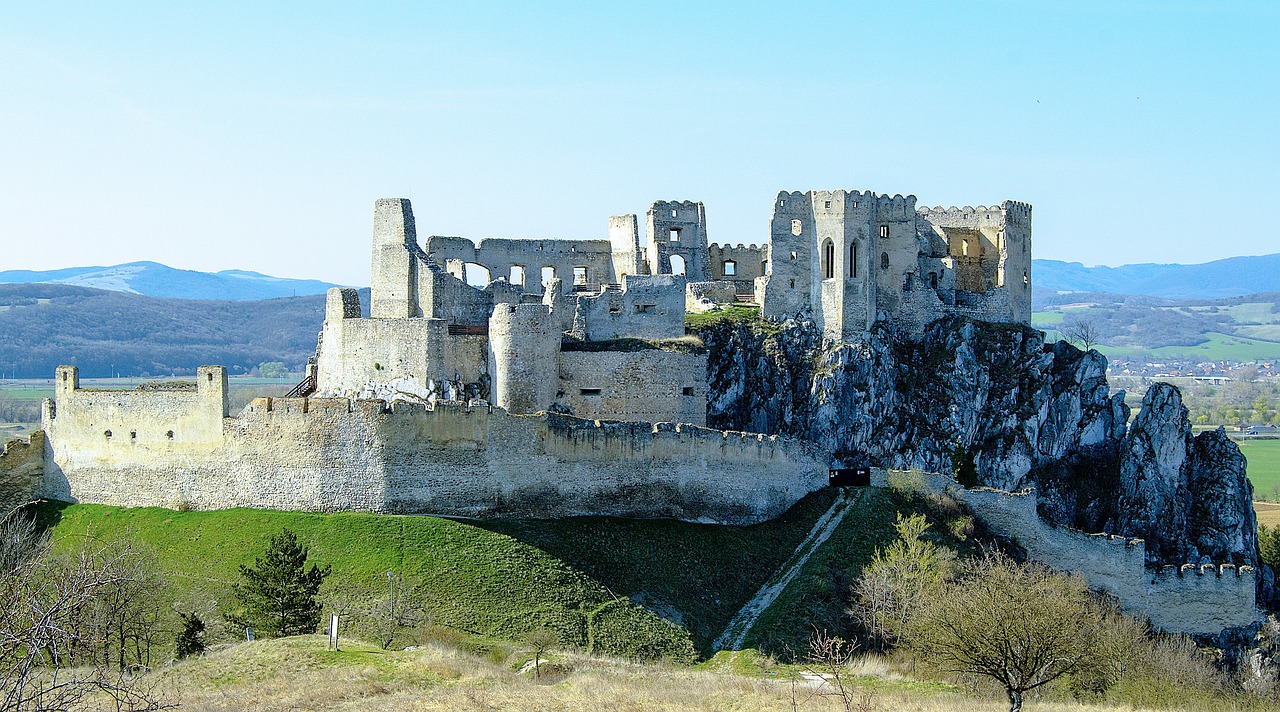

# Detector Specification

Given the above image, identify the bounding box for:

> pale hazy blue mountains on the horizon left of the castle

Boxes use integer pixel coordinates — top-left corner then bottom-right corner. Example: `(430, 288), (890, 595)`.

(0, 263), (337, 301)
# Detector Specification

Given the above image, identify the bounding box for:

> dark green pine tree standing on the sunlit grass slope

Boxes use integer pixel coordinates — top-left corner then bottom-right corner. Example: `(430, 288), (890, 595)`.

(228, 529), (332, 638)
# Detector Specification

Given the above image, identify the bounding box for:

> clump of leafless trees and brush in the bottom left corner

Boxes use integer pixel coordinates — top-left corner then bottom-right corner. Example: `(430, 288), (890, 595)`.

(0, 514), (164, 712)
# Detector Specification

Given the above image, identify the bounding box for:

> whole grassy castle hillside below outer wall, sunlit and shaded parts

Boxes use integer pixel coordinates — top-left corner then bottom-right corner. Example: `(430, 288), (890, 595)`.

(27, 490), (960, 659)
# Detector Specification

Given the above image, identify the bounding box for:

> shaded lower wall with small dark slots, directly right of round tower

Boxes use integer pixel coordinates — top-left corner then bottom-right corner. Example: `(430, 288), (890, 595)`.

(557, 348), (707, 425)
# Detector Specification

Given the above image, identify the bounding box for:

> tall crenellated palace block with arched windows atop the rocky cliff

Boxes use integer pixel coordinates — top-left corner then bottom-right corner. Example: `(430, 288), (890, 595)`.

(756, 191), (1032, 341)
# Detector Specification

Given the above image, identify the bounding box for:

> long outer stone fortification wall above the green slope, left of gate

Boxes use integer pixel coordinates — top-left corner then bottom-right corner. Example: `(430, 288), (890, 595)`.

(41, 398), (828, 524)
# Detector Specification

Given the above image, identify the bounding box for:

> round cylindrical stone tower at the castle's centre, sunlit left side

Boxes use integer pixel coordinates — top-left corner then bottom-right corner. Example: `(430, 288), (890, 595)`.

(489, 303), (563, 414)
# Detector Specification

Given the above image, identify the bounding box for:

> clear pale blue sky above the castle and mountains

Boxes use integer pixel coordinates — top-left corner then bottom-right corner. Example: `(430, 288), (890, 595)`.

(0, 0), (1280, 284)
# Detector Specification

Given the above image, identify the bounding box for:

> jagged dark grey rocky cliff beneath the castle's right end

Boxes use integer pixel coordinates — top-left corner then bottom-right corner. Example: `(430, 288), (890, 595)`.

(699, 319), (1258, 563)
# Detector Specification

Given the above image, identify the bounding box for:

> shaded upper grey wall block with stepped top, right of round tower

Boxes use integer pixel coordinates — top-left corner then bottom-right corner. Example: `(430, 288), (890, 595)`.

(572, 274), (685, 341)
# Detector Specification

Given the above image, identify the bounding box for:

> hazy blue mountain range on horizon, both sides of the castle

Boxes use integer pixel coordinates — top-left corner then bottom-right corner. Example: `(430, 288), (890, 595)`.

(0, 254), (1280, 301)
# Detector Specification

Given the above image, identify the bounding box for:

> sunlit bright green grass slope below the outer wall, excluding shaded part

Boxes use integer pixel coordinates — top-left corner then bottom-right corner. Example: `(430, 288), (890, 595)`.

(32, 505), (694, 661)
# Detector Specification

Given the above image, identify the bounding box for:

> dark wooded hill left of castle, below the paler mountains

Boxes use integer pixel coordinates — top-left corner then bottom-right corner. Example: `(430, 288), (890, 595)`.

(0, 284), (369, 378)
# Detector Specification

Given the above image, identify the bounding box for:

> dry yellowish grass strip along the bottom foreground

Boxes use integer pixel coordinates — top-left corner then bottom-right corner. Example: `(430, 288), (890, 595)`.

(70, 635), (1228, 712)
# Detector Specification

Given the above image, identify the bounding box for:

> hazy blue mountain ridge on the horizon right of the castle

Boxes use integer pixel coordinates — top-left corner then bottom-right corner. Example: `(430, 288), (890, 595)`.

(1032, 254), (1280, 300)
